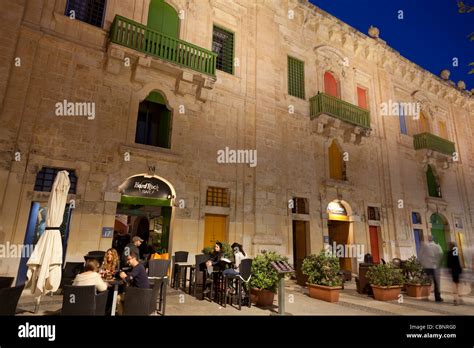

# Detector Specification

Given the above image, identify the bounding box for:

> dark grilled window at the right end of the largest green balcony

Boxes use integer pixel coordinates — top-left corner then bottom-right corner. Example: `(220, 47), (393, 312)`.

(212, 26), (234, 74)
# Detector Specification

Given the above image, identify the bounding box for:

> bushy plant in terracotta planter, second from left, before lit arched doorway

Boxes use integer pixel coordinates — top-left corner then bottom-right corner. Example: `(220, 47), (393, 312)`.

(302, 250), (342, 302)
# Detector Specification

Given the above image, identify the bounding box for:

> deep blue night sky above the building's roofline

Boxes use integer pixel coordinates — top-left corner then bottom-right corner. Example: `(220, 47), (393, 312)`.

(310, 0), (474, 89)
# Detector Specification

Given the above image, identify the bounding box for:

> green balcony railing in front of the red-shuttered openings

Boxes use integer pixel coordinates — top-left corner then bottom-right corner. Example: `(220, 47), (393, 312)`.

(309, 92), (370, 129)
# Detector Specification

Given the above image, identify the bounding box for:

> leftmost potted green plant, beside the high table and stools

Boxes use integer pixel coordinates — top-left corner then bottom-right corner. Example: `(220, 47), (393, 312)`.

(249, 251), (288, 307)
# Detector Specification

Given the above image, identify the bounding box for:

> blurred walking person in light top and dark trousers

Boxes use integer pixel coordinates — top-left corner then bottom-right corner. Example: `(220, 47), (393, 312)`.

(419, 236), (443, 302)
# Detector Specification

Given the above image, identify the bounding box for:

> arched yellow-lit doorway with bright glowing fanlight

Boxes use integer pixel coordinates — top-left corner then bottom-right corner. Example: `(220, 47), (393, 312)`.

(327, 200), (354, 272)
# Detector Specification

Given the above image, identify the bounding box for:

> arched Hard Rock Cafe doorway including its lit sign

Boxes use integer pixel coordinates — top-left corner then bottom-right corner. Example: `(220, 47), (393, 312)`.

(114, 174), (176, 256)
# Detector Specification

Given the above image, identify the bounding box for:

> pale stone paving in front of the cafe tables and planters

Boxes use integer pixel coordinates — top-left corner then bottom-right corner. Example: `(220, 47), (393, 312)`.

(17, 277), (474, 316)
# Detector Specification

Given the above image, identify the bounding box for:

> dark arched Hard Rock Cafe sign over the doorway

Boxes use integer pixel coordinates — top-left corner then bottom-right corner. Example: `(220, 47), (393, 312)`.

(119, 175), (172, 199)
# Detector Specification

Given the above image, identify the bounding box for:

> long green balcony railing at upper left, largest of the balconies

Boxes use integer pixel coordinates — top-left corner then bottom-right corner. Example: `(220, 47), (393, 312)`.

(110, 15), (217, 76)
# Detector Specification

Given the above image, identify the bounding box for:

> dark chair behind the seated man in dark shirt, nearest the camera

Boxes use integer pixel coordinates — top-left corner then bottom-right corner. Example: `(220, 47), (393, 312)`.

(123, 281), (161, 316)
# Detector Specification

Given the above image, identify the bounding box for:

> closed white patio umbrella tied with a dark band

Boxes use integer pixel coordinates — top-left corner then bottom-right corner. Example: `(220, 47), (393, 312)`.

(26, 170), (71, 312)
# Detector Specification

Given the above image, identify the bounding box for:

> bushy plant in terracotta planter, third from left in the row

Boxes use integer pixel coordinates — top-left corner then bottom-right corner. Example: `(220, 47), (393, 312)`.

(366, 263), (405, 301)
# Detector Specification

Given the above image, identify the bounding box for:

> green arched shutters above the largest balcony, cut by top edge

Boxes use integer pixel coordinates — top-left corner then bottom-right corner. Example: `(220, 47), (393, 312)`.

(147, 0), (179, 38)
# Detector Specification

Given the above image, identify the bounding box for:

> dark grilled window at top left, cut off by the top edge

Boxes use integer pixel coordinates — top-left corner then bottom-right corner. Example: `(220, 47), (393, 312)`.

(65, 0), (107, 28)
